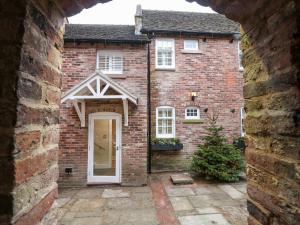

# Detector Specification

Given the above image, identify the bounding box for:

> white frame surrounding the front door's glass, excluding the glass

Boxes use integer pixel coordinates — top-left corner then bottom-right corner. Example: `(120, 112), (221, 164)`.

(87, 112), (122, 184)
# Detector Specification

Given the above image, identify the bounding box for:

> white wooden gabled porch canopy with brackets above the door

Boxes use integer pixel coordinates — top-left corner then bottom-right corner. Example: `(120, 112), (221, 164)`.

(61, 71), (138, 127)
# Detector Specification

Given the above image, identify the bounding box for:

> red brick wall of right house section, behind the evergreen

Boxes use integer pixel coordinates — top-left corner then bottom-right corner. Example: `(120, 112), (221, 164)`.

(151, 36), (243, 170)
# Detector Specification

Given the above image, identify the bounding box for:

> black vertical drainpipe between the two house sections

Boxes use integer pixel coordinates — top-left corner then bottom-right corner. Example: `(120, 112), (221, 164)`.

(147, 43), (152, 173)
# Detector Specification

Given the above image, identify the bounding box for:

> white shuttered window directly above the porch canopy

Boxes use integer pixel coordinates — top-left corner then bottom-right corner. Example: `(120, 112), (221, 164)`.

(97, 51), (123, 74)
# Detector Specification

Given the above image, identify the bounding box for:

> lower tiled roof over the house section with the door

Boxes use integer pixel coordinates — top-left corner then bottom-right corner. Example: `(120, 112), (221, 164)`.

(64, 24), (149, 43)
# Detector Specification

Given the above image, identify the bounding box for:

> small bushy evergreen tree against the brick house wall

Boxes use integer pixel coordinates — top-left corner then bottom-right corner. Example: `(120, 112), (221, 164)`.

(191, 112), (243, 182)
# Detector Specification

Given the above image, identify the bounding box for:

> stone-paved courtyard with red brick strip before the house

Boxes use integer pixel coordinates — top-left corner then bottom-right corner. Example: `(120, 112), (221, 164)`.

(56, 174), (247, 225)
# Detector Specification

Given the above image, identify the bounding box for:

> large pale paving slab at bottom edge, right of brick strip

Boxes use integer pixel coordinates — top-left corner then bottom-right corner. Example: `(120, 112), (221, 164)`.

(179, 214), (230, 225)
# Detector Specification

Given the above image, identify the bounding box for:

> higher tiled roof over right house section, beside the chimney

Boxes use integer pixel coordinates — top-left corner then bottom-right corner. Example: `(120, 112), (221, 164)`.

(142, 10), (240, 35)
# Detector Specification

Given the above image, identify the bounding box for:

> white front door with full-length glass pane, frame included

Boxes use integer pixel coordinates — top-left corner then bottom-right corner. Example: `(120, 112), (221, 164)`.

(88, 112), (122, 184)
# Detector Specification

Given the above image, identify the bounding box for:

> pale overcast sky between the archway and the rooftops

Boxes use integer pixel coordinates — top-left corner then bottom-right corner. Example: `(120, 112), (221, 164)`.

(68, 0), (214, 24)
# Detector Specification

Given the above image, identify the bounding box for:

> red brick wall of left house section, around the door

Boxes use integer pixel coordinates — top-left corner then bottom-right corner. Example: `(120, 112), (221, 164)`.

(59, 43), (147, 186)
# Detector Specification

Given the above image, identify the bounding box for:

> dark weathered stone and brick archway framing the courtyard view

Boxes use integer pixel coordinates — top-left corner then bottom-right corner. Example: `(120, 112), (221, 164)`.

(0, 0), (300, 225)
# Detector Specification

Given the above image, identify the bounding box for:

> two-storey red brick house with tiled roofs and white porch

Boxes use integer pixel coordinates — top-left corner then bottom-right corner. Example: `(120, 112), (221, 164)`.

(59, 7), (243, 186)
